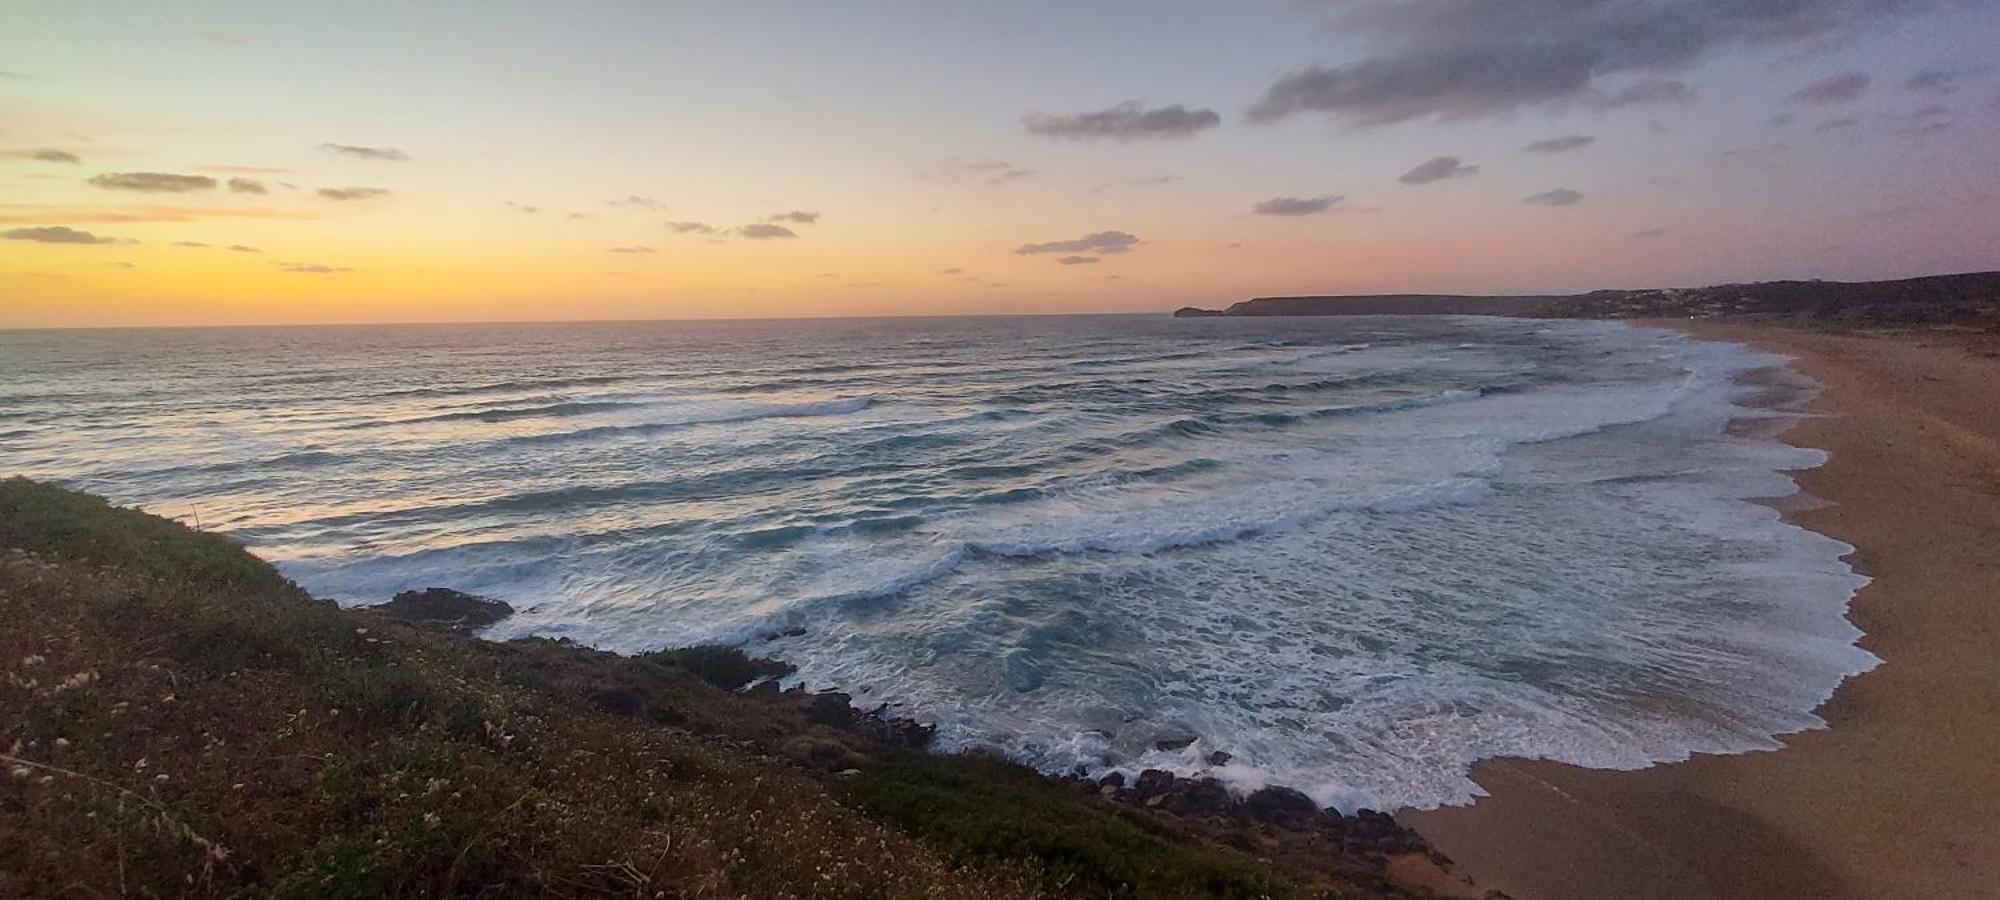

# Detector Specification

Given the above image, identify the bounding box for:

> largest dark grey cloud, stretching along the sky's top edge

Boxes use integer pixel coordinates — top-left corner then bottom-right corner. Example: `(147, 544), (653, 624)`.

(1248, 0), (1932, 126)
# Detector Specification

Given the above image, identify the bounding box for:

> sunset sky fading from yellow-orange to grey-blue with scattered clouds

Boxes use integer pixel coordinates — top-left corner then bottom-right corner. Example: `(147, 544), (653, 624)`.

(0, 0), (2000, 328)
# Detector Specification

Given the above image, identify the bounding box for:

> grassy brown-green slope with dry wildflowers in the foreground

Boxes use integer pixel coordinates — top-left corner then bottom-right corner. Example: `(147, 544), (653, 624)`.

(0, 478), (1424, 898)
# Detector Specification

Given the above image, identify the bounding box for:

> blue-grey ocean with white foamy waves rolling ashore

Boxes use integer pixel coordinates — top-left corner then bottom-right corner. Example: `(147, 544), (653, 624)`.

(0, 316), (1876, 810)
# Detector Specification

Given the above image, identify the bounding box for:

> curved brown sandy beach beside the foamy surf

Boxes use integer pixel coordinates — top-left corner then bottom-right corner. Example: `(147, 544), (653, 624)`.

(1400, 322), (2000, 900)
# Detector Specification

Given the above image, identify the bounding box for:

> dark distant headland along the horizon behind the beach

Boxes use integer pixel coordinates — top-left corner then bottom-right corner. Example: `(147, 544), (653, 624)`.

(1174, 272), (2000, 328)
